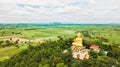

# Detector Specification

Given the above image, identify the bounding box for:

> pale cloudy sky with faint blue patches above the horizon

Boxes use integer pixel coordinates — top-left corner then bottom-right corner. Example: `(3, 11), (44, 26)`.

(0, 0), (120, 23)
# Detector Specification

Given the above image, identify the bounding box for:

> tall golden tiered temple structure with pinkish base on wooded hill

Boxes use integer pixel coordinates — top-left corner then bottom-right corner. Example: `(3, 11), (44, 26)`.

(71, 33), (89, 60)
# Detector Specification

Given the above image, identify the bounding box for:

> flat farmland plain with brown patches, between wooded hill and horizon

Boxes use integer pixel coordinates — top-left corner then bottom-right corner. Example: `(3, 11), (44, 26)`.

(0, 24), (120, 65)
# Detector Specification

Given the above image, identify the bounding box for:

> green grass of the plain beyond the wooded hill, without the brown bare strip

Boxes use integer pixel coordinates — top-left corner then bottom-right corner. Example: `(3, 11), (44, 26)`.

(0, 25), (120, 61)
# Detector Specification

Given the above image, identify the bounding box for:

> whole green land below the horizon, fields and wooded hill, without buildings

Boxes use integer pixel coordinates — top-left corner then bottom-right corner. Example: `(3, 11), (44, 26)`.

(0, 24), (120, 67)
